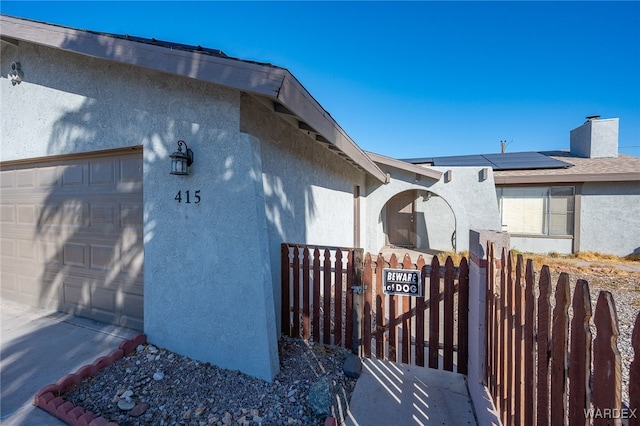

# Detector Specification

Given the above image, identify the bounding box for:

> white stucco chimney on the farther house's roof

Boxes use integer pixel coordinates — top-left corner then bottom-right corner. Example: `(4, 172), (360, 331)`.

(570, 115), (619, 158)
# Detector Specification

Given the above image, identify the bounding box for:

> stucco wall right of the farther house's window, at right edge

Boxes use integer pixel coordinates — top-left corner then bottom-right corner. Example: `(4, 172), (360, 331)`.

(577, 182), (640, 256)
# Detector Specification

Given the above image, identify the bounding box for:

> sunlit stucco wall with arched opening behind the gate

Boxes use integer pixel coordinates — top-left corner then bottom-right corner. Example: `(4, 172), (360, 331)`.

(364, 165), (501, 253)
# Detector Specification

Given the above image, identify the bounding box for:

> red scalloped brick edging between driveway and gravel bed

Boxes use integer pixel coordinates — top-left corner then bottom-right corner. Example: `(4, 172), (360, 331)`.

(33, 334), (147, 426)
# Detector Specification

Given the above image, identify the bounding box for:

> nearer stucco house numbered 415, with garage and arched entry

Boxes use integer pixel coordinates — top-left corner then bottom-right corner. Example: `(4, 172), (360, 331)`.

(0, 15), (500, 380)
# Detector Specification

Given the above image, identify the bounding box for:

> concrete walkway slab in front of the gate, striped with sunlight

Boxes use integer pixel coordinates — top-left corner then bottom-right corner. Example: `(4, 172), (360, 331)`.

(345, 359), (476, 426)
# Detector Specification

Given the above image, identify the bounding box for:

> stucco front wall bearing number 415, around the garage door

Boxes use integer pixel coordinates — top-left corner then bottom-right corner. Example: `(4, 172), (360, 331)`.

(0, 40), (278, 380)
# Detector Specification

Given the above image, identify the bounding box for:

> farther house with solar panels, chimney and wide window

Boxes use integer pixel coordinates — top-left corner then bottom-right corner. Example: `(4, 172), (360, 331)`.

(405, 116), (640, 256)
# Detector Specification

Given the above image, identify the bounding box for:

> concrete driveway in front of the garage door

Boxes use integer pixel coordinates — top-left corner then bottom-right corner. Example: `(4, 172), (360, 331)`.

(0, 300), (139, 426)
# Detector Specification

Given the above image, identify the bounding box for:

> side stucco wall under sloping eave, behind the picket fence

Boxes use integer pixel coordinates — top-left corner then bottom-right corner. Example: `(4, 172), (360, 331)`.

(240, 95), (365, 330)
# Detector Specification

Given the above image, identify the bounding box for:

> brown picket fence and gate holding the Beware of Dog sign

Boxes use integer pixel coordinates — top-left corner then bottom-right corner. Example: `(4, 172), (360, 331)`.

(282, 244), (469, 374)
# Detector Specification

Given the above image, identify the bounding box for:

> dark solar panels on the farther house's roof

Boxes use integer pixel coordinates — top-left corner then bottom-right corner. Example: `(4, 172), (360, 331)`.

(402, 152), (572, 170)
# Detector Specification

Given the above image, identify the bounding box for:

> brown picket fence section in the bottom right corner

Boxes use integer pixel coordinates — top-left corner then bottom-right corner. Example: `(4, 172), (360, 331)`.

(485, 244), (640, 426)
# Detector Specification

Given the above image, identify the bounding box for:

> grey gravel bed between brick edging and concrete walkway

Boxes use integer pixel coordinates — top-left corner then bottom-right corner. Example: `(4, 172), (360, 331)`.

(65, 337), (356, 426)
